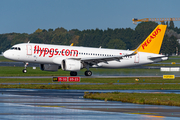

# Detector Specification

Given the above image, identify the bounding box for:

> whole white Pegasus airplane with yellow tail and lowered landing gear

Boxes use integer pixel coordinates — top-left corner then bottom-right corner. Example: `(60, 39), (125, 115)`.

(3, 25), (168, 76)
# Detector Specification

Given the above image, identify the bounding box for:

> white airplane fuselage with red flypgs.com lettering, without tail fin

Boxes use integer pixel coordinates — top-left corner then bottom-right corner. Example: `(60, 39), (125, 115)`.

(4, 43), (168, 68)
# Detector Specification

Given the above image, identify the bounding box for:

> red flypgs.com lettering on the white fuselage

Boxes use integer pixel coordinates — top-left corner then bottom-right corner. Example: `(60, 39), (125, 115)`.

(34, 45), (78, 58)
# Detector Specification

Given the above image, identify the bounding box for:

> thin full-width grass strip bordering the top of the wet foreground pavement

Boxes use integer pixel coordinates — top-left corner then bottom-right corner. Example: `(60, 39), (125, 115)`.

(0, 83), (180, 90)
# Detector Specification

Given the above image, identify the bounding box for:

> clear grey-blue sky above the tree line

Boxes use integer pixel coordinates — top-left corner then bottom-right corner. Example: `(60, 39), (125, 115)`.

(0, 0), (180, 34)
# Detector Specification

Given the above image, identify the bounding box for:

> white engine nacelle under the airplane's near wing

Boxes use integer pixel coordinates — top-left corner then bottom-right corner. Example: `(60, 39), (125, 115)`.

(61, 59), (83, 71)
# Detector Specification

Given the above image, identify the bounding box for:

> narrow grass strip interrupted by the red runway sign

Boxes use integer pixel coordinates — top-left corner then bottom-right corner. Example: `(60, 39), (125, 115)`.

(0, 76), (180, 84)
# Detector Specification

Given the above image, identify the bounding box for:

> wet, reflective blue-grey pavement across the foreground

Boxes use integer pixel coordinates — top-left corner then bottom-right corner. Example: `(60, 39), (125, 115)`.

(0, 89), (180, 120)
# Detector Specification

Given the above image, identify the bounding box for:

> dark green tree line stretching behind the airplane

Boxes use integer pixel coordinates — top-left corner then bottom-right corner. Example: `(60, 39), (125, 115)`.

(0, 21), (180, 54)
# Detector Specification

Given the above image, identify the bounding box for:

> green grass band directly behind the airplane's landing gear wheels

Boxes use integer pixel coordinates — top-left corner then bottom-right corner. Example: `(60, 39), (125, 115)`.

(0, 66), (179, 77)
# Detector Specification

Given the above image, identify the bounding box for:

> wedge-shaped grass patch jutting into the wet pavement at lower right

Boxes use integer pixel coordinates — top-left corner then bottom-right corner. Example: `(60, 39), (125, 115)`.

(84, 92), (180, 106)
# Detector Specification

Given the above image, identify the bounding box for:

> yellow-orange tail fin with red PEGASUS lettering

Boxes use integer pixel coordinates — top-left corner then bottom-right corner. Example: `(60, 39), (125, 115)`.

(134, 25), (167, 54)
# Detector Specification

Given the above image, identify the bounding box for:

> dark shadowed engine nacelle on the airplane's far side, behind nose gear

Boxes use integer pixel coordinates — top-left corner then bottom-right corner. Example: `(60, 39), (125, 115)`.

(40, 64), (59, 71)
